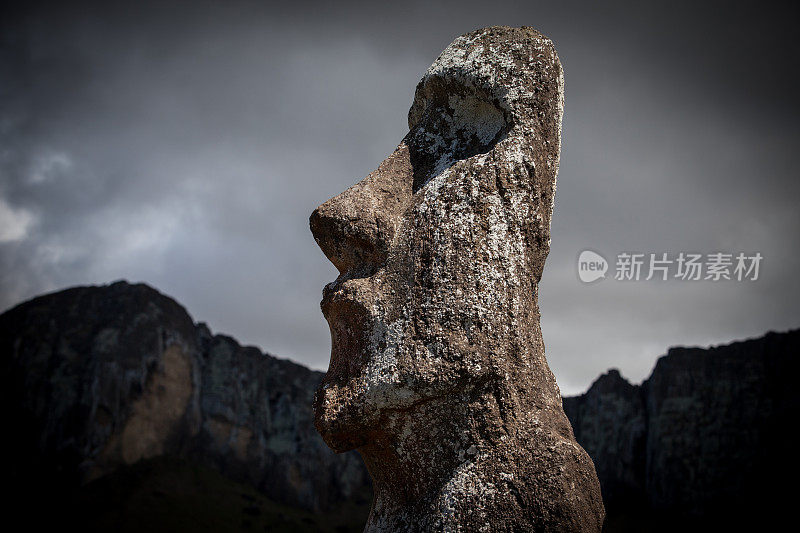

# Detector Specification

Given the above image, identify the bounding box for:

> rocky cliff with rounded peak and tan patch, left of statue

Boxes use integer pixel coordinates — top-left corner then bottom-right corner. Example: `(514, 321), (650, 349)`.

(0, 282), (369, 510)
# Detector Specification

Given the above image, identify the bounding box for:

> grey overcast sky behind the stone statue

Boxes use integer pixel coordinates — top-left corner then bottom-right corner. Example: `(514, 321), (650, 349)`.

(0, 1), (800, 394)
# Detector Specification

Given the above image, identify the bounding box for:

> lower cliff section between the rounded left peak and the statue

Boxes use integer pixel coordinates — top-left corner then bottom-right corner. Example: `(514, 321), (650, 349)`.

(191, 325), (369, 510)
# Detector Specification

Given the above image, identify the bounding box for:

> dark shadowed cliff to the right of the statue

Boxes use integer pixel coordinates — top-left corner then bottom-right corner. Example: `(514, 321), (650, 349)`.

(564, 330), (800, 526)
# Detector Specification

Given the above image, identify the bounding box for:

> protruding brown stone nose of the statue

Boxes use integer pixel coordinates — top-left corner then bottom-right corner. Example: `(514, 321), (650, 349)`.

(310, 144), (413, 275)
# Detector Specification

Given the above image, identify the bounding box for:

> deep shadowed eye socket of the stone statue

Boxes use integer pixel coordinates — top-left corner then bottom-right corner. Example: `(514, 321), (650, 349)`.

(406, 78), (512, 192)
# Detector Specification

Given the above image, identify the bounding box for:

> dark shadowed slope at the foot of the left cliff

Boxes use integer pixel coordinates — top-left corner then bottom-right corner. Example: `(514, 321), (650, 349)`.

(50, 458), (369, 533)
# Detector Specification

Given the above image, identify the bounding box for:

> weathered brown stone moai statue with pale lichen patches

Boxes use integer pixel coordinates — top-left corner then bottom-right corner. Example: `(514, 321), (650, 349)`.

(311, 27), (604, 532)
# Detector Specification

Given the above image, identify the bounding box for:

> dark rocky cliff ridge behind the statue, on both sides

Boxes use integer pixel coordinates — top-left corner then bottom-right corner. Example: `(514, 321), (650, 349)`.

(0, 282), (800, 531)
